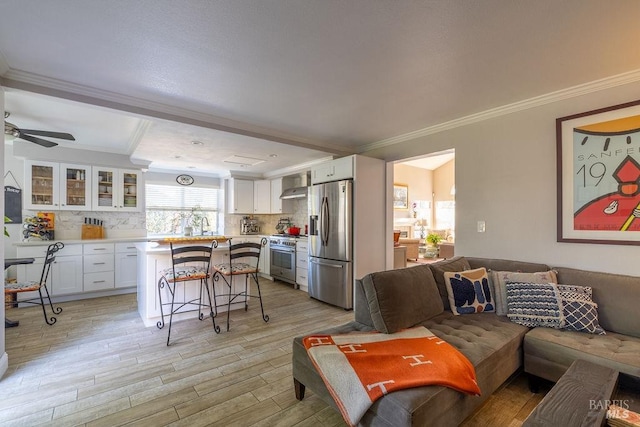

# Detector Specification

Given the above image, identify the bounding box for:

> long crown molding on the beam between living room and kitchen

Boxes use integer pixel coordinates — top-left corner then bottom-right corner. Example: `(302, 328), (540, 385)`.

(0, 69), (354, 156)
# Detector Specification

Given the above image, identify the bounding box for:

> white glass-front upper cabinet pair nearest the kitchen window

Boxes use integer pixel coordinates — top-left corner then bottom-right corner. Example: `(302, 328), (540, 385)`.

(91, 166), (144, 212)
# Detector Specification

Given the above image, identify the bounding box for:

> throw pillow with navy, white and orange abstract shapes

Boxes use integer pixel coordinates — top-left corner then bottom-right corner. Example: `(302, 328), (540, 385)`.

(444, 268), (495, 315)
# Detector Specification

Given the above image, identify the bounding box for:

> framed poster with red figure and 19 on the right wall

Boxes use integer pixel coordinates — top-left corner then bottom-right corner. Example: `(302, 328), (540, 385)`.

(556, 100), (640, 245)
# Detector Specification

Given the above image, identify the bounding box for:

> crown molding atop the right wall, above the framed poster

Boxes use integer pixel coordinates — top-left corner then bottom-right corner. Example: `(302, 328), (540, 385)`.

(359, 70), (640, 153)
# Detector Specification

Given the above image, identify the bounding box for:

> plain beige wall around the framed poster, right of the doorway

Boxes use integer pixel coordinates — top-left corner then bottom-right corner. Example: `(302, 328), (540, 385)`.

(363, 79), (640, 275)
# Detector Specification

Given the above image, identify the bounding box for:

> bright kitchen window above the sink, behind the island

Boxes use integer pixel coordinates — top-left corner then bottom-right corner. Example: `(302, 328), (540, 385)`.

(145, 184), (224, 234)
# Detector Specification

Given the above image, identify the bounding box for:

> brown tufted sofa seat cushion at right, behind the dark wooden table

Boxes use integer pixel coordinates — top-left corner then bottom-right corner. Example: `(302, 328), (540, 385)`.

(524, 328), (640, 381)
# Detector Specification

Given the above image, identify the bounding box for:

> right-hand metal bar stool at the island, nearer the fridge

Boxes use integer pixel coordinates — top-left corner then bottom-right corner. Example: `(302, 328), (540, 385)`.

(213, 237), (269, 331)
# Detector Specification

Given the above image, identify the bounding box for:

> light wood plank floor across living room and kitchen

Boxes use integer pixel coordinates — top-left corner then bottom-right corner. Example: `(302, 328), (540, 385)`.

(0, 280), (542, 426)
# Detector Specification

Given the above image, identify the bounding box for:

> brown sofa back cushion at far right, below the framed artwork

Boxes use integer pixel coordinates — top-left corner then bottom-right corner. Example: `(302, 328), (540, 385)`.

(554, 267), (640, 338)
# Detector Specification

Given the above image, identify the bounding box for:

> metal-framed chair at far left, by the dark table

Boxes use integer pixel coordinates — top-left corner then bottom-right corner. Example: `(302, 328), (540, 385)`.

(4, 242), (64, 325)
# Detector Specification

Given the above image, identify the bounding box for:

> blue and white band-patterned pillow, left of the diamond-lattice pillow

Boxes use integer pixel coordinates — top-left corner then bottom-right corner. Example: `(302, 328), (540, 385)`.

(506, 282), (563, 329)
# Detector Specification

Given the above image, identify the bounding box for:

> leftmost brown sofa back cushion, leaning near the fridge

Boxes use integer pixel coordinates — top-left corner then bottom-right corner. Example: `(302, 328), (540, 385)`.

(356, 265), (444, 334)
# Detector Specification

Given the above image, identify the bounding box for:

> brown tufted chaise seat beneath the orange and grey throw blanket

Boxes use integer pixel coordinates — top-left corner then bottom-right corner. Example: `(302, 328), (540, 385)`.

(293, 312), (529, 426)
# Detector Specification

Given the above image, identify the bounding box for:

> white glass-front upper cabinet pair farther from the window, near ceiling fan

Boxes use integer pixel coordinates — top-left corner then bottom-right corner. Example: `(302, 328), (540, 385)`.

(24, 161), (91, 210)
